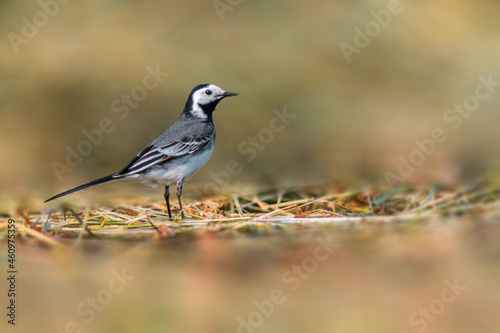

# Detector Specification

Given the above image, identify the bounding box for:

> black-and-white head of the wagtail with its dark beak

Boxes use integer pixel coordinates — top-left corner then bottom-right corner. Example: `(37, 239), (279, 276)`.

(184, 84), (238, 118)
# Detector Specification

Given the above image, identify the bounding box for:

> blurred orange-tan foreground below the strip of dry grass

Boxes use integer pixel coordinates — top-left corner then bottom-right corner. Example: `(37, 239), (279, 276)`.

(0, 218), (500, 333)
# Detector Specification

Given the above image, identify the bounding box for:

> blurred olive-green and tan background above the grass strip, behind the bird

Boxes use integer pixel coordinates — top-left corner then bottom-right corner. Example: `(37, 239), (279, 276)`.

(0, 0), (500, 204)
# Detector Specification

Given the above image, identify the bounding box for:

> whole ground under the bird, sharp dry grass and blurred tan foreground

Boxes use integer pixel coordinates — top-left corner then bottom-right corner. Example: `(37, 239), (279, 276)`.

(1, 186), (500, 332)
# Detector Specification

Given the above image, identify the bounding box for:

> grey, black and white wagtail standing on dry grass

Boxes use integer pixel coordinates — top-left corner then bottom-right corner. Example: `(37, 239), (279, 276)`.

(45, 84), (238, 220)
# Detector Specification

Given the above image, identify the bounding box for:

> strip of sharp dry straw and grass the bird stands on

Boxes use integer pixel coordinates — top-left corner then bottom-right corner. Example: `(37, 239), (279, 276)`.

(1, 186), (500, 245)
